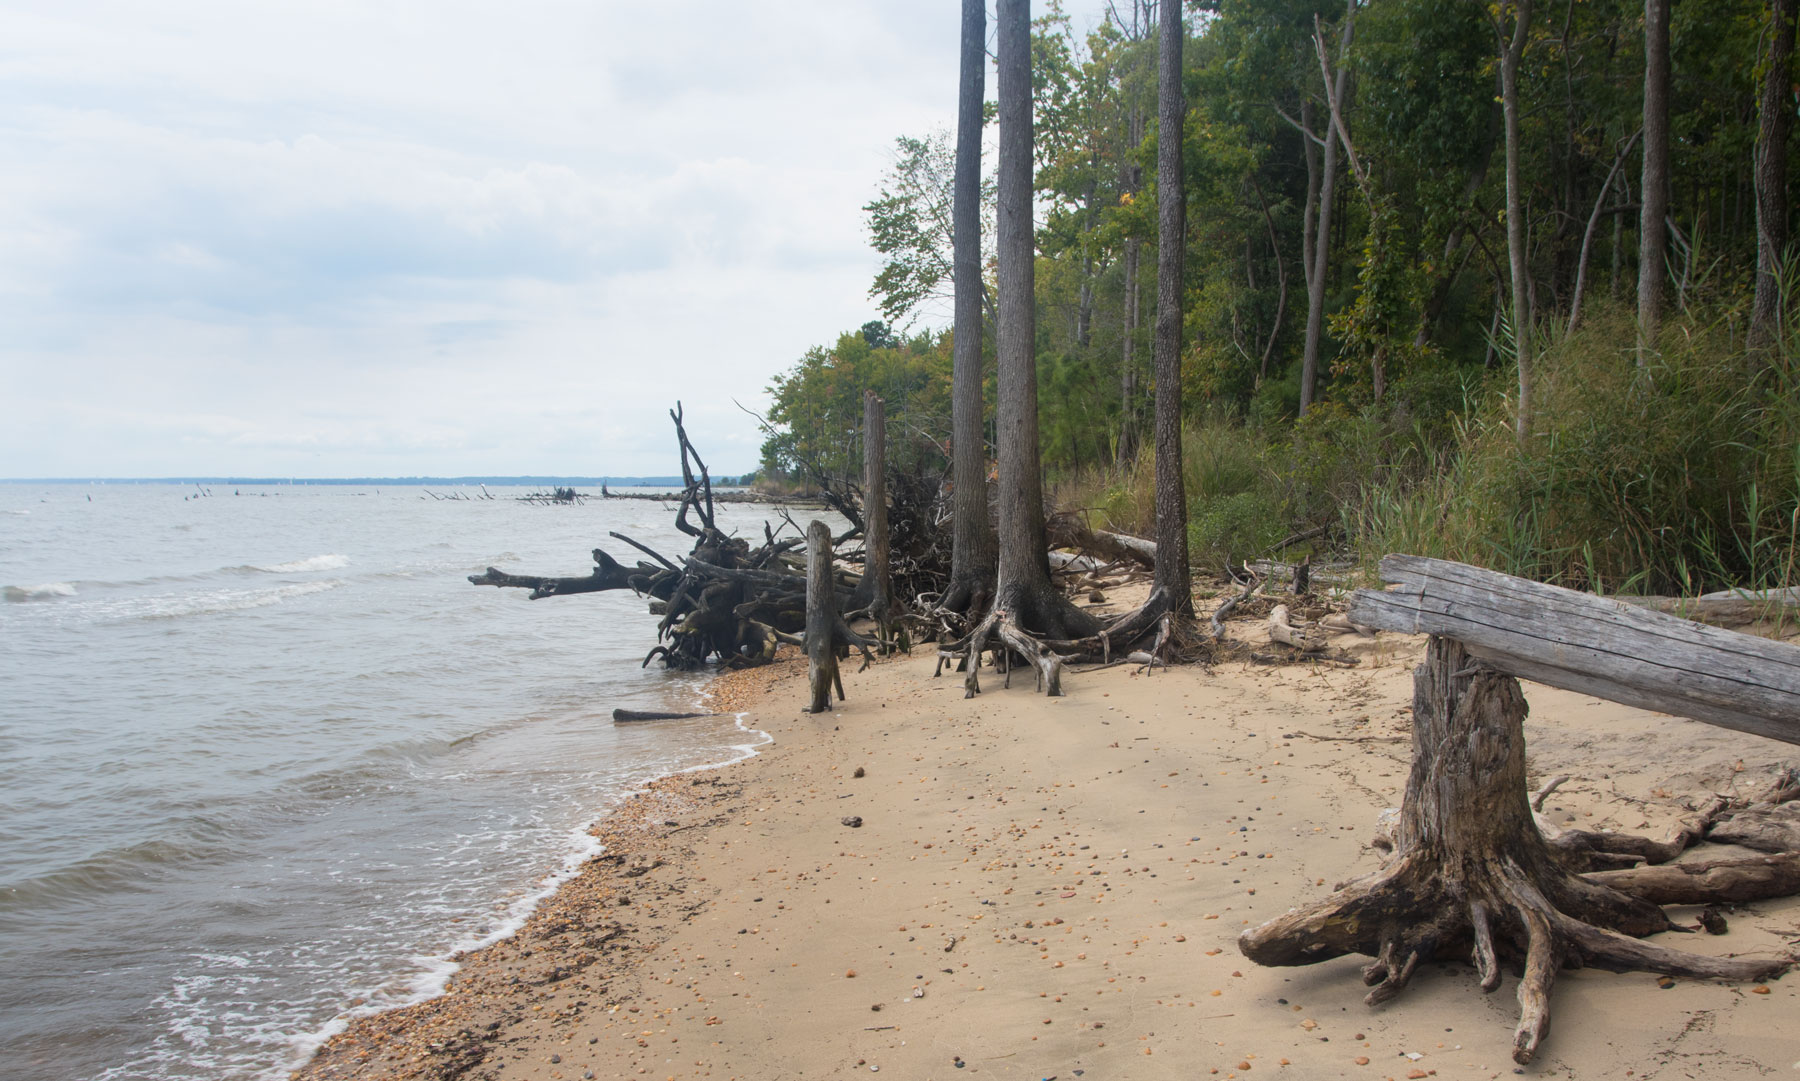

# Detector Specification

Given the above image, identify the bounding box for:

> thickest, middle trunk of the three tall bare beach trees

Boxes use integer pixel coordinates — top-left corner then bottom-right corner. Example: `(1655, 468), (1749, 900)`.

(994, 0), (1100, 639)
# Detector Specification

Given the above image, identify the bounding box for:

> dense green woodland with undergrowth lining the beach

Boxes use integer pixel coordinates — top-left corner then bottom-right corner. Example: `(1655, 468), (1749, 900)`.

(763, 0), (1800, 592)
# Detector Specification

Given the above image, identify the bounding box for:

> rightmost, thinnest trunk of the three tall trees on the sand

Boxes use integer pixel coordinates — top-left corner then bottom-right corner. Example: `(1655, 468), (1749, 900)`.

(1156, 0), (1193, 619)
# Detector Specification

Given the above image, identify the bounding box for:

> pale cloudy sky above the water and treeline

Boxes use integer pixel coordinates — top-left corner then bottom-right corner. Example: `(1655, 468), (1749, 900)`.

(0, 0), (1103, 477)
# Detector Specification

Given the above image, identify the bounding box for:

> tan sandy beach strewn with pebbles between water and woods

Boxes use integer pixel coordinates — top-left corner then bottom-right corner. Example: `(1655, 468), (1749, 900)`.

(297, 611), (1800, 1081)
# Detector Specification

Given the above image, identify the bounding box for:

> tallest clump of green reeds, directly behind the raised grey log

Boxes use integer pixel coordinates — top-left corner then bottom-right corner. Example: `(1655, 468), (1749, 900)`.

(1354, 302), (1800, 594)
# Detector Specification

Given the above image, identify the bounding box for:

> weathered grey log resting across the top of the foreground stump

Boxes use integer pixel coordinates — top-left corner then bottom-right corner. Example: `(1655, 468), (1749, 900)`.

(1350, 556), (1800, 743)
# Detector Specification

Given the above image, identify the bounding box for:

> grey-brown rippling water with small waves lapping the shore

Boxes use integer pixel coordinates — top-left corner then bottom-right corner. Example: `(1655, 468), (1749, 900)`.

(0, 484), (795, 1081)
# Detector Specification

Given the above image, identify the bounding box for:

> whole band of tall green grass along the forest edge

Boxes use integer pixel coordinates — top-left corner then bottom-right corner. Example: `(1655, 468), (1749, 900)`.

(1058, 298), (1800, 595)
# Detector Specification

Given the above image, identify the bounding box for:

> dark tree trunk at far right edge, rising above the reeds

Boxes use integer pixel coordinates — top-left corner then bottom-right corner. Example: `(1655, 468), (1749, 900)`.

(1750, 0), (1795, 362)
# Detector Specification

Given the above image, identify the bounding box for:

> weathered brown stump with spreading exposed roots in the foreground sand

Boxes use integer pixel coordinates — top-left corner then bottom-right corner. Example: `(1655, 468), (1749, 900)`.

(1238, 637), (1787, 1065)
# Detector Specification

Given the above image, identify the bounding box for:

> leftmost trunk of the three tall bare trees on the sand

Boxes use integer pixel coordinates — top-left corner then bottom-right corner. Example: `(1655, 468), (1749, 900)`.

(943, 0), (994, 613)
